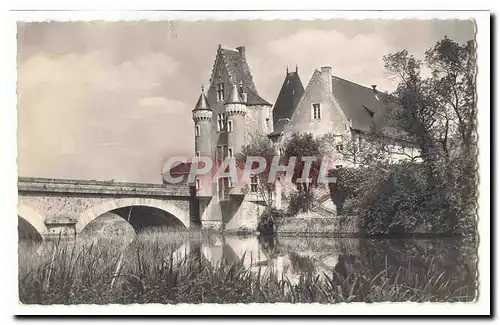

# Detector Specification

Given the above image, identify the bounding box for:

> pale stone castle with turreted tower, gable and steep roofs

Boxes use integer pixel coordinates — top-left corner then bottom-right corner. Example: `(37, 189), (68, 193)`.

(182, 45), (418, 231)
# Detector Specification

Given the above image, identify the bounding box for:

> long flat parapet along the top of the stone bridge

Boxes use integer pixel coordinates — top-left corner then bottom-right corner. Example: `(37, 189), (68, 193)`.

(18, 177), (191, 197)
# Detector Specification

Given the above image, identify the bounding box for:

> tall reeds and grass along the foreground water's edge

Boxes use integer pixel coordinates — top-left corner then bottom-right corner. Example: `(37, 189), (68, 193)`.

(19, 233), (474, 304)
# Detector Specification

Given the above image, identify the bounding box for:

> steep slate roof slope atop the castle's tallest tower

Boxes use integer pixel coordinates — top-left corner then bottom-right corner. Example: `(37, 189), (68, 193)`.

(214, 46), (271, 106)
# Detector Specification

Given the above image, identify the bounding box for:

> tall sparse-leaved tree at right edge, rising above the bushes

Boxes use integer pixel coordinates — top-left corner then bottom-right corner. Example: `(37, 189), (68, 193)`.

(384, 37), (477, 232)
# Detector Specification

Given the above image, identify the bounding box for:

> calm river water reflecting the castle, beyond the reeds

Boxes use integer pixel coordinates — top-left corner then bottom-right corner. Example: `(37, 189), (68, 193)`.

(201, 236), (476, 288)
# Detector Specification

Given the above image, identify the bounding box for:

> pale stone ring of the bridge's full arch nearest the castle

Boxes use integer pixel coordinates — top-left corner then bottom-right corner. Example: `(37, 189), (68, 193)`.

(75, 198), (190, 233)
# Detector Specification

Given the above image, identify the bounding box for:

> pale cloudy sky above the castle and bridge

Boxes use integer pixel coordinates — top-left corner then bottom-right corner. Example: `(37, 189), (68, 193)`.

(17, 19), (475, 183)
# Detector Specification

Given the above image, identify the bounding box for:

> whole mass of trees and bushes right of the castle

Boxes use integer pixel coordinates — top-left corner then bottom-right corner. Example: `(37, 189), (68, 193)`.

(331, 37), (477, 234)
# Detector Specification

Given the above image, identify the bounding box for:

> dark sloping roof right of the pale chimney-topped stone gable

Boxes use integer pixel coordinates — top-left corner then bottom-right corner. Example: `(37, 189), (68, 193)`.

(332, 76), (394, 132)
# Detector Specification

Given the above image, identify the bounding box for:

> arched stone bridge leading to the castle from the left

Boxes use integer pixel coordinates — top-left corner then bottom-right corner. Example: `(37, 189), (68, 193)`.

(17, 177), (199, 238)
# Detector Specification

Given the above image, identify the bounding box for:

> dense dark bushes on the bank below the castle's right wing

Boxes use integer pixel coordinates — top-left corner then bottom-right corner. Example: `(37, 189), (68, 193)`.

(330, 163), (466, 235)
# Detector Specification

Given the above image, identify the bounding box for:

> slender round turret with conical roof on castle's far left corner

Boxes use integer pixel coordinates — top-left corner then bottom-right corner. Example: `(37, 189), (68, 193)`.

(193, 86), (213, 196)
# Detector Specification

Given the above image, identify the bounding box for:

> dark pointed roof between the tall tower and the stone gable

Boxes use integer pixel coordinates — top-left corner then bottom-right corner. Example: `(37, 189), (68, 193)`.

(273, 70), (304, 126)
